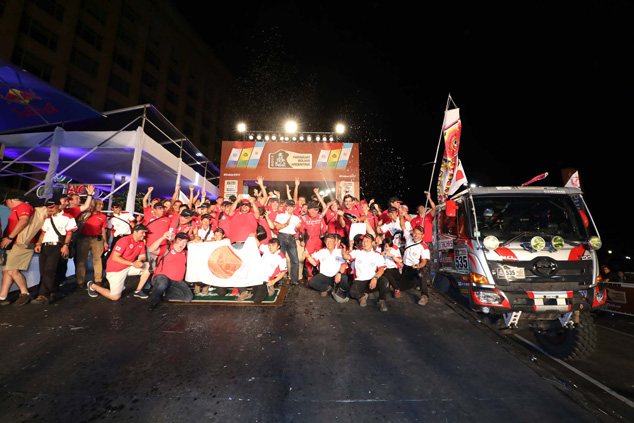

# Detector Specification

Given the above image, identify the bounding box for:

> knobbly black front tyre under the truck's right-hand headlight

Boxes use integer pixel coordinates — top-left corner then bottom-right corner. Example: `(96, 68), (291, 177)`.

(535, 312), (597, 361)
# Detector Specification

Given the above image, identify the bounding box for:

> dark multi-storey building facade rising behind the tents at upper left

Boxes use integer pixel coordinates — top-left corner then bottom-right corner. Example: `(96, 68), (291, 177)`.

(0, 0), (235, 165)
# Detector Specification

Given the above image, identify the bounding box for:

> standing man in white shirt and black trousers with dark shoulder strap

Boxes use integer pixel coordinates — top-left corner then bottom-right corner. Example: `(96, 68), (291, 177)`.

(31, 198), (77, 304)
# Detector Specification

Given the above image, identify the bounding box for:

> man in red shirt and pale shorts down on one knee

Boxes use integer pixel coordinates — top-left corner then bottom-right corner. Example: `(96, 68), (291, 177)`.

(87, 224), (150, 301)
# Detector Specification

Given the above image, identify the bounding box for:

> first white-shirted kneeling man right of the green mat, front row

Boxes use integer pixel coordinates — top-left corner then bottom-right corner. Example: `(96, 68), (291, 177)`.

(306, 234), (348, 302)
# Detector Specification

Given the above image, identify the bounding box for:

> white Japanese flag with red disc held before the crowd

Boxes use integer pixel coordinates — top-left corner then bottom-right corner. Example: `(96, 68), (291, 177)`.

(185, 237), (267, 288)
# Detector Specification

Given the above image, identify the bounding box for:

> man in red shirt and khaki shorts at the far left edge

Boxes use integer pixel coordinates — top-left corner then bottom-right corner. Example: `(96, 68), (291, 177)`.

(0, 194), (33, 305)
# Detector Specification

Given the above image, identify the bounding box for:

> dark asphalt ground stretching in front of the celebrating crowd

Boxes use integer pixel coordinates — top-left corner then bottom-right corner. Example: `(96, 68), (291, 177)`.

(0, 278), (633, 423)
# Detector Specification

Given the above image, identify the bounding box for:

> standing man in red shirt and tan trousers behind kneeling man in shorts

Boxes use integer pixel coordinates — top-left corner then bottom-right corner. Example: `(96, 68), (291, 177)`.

(75, 200), (108, 288)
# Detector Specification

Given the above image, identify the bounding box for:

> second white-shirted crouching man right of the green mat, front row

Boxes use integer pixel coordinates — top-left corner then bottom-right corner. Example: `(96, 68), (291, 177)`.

(342, 234), (390, 311)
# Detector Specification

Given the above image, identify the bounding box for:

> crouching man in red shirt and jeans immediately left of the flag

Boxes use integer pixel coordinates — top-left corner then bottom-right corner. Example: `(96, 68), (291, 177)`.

(148, 232), (194, 310)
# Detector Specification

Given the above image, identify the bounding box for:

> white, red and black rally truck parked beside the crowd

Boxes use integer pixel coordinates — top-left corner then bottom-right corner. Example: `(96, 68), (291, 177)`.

(432, 187), (606, 360)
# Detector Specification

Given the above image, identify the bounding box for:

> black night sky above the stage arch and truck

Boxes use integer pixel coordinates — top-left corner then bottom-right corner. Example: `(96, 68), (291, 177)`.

(178, 1), (634, 268)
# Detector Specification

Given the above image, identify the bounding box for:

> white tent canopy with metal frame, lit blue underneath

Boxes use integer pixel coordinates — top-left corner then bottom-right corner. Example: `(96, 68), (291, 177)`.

(0, 105), (219, 211)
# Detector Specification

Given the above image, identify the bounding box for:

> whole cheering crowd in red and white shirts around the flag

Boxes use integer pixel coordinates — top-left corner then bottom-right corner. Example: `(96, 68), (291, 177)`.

(0, 177), (436, 311)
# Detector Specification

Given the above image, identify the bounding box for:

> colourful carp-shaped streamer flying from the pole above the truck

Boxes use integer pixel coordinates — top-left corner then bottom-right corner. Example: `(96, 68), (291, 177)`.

(437, 109), (462, 203)
